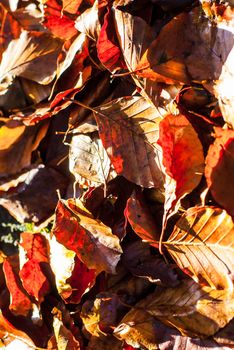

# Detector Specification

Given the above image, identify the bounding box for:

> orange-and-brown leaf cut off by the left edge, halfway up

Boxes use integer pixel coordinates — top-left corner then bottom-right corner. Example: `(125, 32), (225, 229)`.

(0, 118), (48, 177)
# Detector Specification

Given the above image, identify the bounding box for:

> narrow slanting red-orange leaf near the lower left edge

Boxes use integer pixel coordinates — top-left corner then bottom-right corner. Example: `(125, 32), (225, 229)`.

(3, 256), (32, 316)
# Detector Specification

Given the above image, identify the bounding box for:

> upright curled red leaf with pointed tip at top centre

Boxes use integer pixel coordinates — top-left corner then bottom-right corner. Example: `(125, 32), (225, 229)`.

(97, 7), (126, 72)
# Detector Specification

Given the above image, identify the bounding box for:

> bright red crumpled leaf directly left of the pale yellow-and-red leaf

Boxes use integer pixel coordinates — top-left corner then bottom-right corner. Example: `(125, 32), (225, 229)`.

(19, 232), (51, 303)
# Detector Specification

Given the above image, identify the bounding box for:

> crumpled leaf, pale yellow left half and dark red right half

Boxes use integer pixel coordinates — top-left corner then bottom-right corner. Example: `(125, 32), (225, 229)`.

(50, 236), (96, 303)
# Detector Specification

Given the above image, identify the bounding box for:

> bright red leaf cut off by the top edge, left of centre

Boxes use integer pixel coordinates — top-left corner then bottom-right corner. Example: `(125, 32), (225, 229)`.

(43, 0), (77, 40)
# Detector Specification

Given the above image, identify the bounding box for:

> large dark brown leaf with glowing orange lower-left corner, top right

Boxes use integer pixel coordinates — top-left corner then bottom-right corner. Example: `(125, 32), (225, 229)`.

(136, 8), (225, 84)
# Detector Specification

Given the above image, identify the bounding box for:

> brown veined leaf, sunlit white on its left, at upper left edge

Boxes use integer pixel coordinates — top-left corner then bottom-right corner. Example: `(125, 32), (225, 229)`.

(0, 31), (62, 93)
